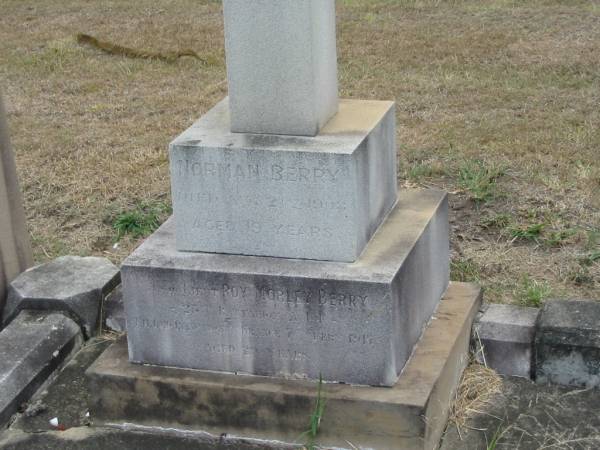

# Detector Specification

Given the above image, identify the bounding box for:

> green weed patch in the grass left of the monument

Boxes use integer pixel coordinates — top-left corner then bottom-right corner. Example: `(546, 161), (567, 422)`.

(113, 202), (171, 241)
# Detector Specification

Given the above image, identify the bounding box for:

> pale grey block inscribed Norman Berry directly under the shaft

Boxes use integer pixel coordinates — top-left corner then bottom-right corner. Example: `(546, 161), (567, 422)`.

(170, 96), (397, 262)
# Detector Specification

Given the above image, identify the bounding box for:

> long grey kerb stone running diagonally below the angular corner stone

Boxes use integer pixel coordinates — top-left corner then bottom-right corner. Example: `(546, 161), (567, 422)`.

(0, 311), (82, 426)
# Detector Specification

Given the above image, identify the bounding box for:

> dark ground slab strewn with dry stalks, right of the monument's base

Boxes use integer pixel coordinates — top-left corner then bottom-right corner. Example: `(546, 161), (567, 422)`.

(440, 370), (600, 450)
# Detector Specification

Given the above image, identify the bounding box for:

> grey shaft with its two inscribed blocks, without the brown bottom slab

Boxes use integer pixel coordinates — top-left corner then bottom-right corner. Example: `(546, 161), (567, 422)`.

(122, 0), (449, 386)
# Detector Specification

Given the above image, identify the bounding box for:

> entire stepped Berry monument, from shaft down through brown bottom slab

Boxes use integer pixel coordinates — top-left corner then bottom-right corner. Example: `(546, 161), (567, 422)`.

(89, 0), (480, 449)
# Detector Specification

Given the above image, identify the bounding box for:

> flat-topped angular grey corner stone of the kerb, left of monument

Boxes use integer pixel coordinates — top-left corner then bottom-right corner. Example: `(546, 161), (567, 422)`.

(3, 256), (120, 336)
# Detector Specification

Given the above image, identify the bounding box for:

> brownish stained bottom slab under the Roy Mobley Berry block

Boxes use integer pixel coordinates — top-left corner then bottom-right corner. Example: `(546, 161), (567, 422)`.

(87, 283), (480, 450)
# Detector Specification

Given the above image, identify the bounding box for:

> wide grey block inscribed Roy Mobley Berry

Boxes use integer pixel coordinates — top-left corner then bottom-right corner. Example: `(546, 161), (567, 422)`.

(122, 191), (449, 386)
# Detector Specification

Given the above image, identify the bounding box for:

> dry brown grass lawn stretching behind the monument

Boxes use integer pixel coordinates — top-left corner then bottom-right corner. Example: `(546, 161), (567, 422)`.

(0, 0), (600, 303)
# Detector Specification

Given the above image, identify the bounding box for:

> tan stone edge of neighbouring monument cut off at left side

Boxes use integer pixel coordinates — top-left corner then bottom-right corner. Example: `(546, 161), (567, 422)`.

(0, 93), (33, 329)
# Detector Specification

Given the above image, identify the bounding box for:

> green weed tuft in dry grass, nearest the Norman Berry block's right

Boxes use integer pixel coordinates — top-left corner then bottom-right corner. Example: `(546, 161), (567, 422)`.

(458, 160), (504, 202)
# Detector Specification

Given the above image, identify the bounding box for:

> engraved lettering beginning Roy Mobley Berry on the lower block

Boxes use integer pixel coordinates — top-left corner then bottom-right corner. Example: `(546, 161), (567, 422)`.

(128, 275), (389, 364)
